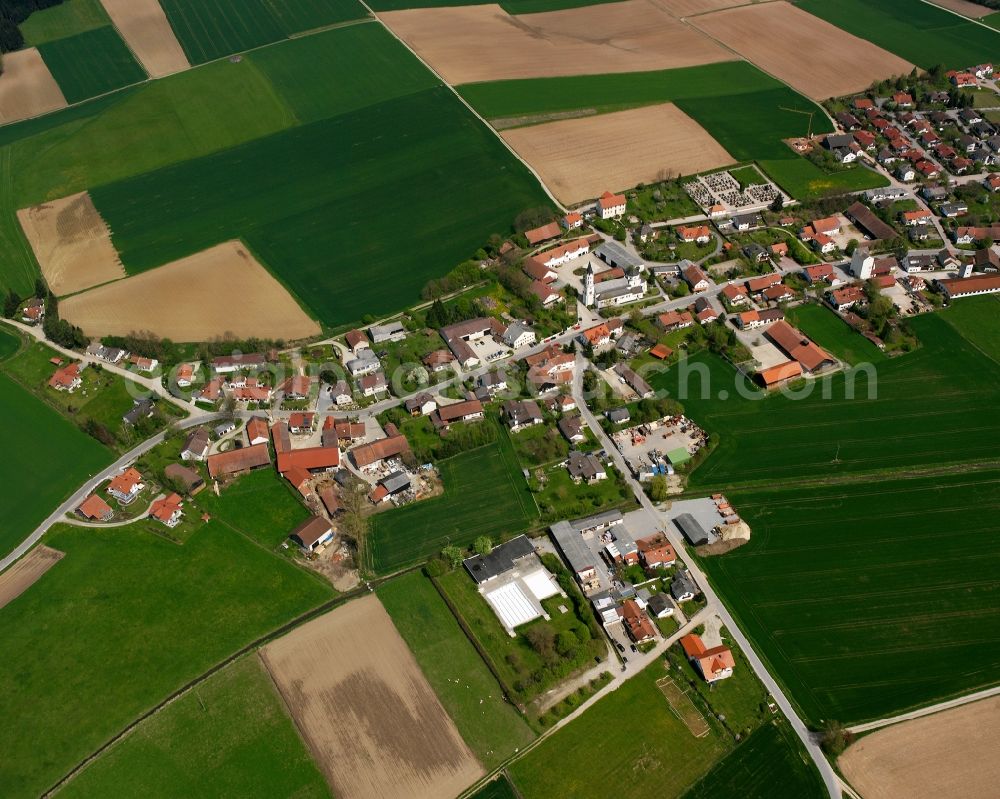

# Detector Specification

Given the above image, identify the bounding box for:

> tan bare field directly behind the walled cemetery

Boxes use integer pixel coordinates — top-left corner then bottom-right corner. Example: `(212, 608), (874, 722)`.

(501, 103), (735, 204)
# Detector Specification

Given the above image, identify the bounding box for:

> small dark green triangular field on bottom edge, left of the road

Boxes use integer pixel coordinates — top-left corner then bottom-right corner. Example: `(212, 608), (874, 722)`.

(683, 722), (828, 799)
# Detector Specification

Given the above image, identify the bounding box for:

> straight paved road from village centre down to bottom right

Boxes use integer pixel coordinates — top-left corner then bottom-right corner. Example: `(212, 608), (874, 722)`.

(573, 352), (841, 799)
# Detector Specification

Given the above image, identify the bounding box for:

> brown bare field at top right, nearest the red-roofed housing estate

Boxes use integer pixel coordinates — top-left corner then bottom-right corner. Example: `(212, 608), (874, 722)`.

(690, 0), (913, 100)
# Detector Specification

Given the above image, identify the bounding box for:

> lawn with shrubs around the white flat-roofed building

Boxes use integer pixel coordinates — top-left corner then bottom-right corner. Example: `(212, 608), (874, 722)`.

(438, 555), (607, 710)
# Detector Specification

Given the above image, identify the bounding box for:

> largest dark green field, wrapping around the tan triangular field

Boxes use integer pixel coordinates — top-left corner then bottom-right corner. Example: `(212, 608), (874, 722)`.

(91, 88), (545, 325)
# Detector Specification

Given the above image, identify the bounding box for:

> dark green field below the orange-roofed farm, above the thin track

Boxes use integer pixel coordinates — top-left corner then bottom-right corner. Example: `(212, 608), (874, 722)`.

(647, 315), (1000, 490)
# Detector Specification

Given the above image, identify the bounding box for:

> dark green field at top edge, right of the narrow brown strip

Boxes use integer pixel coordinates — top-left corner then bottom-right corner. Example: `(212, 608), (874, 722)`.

(160, 0), (366, 64)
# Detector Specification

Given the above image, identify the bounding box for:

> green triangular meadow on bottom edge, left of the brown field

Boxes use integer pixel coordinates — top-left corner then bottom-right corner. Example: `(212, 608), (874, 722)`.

(59, 655), (330, 799)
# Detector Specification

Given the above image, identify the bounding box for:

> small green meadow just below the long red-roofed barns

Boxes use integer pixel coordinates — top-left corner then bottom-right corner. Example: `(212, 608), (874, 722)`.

(194, 468), (310, 549)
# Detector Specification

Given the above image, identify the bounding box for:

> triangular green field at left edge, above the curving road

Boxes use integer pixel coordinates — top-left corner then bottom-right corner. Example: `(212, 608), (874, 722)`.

(0, 374), (114, 556)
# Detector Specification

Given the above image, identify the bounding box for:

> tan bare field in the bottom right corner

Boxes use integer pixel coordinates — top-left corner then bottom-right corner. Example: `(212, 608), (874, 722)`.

(837, 697), (1000, 799)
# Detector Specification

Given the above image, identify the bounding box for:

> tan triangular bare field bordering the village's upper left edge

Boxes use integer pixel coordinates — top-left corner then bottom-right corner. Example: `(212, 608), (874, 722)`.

(59, 241), (320, 341)
